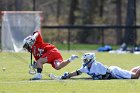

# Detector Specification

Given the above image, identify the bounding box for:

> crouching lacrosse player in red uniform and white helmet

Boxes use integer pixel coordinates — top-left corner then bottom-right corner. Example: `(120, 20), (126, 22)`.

(23, 31), (78, 80)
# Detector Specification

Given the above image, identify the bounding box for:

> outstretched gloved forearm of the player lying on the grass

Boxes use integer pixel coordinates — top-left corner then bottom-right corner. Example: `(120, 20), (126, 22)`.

(61, 70), (82, 79)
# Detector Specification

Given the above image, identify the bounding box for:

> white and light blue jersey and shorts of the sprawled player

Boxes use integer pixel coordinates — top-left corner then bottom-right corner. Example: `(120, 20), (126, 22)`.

(79, 61), (132, 79)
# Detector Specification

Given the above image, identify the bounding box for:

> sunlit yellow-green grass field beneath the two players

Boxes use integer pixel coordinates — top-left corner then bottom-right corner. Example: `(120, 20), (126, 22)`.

(0, 51), (140, 93)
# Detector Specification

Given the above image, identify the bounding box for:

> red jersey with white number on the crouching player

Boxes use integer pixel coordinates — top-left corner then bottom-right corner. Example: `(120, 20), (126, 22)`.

(32, 31), (56, 60)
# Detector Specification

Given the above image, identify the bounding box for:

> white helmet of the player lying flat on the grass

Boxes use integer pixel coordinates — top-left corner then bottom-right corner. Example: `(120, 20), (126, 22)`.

(82, 53), (95, 63)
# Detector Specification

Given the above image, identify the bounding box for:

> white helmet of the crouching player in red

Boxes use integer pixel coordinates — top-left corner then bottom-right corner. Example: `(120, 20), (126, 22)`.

(23, 35), (34, 52)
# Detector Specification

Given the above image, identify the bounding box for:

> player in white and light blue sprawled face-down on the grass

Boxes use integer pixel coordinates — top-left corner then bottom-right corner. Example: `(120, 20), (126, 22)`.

(50, 53), (140, 80)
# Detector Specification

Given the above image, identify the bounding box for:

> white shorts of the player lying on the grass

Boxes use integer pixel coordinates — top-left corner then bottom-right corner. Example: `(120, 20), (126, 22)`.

(109, 66), (132, 79)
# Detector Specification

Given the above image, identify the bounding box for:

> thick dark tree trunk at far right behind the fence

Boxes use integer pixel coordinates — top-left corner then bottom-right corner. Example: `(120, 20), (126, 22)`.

(124, 0), (136, 45)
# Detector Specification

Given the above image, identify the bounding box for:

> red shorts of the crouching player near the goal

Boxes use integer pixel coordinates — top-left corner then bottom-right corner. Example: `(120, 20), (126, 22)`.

(42, 48), (63, 68)
